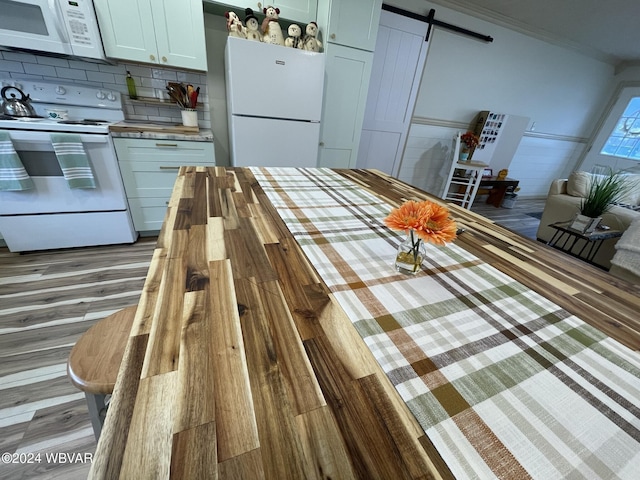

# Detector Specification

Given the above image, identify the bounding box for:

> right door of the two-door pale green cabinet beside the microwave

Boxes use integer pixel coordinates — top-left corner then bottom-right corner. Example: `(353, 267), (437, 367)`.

(151, 0), (207, 71)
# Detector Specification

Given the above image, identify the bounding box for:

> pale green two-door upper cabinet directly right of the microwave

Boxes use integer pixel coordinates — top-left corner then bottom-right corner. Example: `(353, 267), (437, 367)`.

(94, 0), (207, 71)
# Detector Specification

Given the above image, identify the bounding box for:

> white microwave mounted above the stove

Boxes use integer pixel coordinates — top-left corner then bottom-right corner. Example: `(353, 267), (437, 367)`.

(0, 0), (106, 61)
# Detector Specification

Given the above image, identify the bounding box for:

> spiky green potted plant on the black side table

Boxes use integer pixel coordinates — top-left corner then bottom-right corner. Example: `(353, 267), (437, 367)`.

(571, 170), (628, 233)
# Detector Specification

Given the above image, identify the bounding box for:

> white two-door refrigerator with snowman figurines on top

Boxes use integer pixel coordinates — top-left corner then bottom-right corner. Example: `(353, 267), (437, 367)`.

(225, 37), (324, 167)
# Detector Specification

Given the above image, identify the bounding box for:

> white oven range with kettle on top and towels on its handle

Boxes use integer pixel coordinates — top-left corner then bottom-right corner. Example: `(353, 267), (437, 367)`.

(0, 81), (137, 252)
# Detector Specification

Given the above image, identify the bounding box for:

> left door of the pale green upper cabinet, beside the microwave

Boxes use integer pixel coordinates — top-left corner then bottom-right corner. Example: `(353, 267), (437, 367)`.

(94, 0), (158, 63)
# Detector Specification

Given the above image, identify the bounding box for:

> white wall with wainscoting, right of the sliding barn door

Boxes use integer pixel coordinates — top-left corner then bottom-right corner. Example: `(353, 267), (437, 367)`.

(385, 0), (617, 197)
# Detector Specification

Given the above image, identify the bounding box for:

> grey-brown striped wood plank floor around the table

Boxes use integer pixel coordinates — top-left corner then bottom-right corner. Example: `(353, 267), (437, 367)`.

(0, 197), (544, 480)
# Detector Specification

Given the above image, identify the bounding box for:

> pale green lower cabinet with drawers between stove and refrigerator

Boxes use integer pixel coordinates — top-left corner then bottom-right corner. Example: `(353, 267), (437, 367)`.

(113, 138), (215, 232)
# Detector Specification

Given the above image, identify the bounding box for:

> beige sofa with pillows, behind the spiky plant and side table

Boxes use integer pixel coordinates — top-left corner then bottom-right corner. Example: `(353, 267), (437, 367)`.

(537, 172), (640, 270)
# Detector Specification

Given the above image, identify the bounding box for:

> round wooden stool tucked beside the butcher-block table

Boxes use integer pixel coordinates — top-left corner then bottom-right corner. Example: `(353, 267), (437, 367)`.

(67, 306), (137, 441)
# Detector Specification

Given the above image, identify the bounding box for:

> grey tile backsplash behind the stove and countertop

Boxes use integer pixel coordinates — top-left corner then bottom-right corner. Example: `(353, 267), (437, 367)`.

(0, 50), (211, 129)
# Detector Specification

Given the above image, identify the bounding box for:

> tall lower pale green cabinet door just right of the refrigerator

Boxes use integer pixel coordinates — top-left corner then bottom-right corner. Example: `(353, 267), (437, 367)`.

(318, 45), (373, 168)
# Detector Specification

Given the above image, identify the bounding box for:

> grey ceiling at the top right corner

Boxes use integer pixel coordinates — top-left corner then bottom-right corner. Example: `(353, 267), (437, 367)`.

(424, 0), (640, 65)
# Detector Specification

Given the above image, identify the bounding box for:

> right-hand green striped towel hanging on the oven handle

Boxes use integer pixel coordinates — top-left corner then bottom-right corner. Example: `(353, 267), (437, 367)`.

(51, 133), (96, 188)
